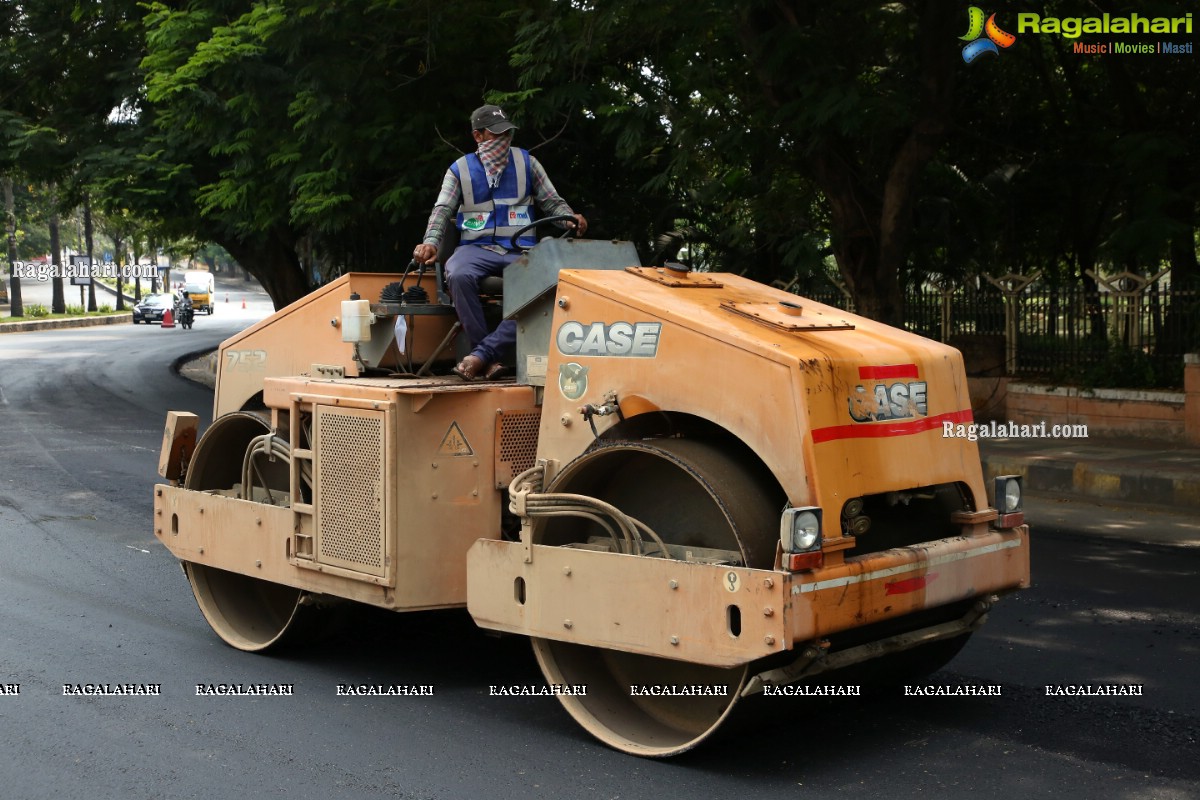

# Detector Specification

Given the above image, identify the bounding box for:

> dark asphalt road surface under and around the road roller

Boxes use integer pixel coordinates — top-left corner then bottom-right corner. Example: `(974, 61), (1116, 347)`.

(0, 284), (1200, 800)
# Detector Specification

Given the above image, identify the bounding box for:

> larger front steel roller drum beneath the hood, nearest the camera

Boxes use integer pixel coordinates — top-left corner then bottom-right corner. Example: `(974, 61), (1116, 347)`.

(533, 439), (784, 757)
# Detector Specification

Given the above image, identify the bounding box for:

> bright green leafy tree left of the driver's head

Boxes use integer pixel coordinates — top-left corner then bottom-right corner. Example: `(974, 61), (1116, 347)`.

(128, 0), (545, 306)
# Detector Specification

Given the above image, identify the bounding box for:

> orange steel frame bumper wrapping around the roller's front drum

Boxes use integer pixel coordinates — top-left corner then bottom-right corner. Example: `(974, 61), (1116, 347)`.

(467, 525), (1030, 667)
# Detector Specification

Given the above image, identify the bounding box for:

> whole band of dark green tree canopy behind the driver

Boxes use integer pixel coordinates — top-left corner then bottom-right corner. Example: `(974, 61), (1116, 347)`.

(0, 0), (1200, 323)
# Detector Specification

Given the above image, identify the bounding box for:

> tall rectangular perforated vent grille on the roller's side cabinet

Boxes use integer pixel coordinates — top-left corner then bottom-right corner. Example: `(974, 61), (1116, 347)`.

(314, 407), (384, 576)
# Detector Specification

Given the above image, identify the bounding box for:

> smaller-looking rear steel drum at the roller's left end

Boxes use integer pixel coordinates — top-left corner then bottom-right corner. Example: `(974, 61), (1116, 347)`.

(184, 411), (312, 651)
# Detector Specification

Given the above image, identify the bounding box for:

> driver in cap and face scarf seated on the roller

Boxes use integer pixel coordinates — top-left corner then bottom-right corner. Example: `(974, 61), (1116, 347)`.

(413, 106), (588, 380)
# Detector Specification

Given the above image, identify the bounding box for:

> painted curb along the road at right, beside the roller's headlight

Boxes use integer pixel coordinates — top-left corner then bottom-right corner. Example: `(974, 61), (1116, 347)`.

(980, 453), (1200, 511)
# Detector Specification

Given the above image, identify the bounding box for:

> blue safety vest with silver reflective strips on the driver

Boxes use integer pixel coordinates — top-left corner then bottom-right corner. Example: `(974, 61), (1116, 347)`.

(450, 148), (538, 247)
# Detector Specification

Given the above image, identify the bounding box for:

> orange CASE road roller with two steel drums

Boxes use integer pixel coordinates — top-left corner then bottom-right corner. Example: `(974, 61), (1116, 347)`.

(154, 232), (1030, 756)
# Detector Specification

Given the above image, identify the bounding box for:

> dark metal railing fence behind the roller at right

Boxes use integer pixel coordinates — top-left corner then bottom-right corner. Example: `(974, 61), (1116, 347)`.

(797, 281), (1200, 387)
